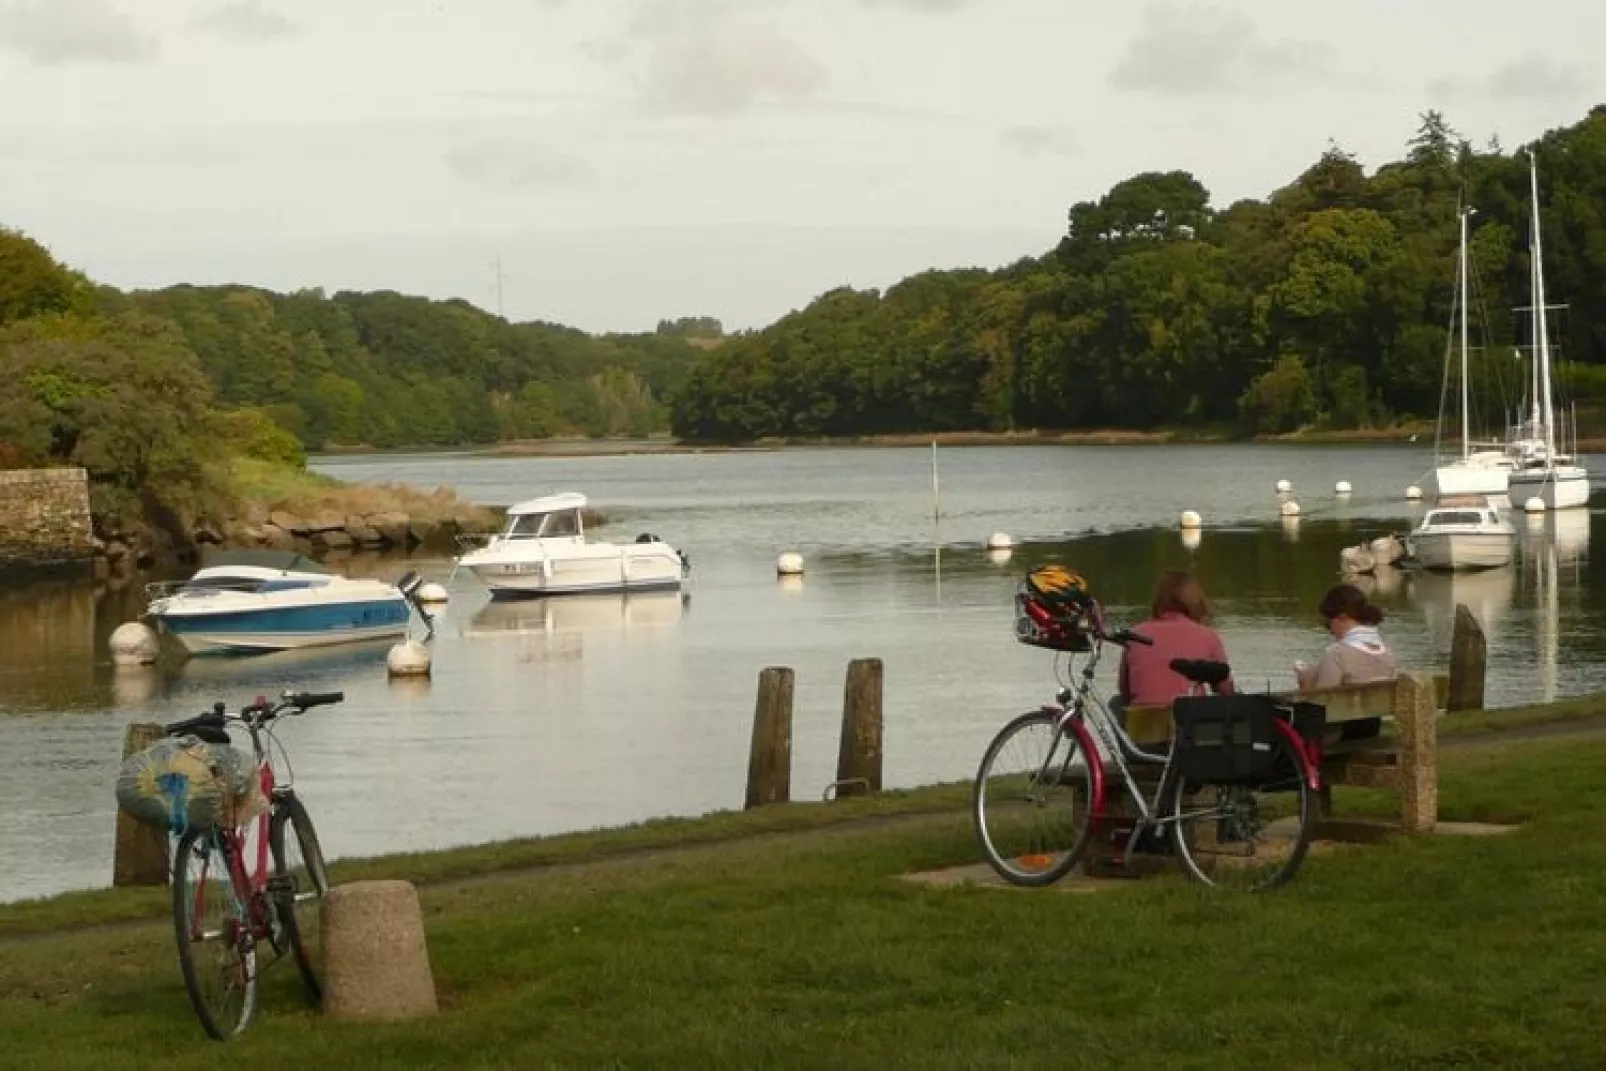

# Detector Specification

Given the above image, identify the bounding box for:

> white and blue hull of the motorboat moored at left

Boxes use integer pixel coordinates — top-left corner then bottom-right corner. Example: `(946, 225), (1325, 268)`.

(151, 593), (411, 655)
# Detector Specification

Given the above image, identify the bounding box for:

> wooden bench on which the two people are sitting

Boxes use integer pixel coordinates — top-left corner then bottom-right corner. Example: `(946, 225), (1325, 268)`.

(1087, 671), (1449, 873)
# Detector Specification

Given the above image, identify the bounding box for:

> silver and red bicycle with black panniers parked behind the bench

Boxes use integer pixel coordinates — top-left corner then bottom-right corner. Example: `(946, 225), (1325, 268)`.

(972, 597), (1322, 891)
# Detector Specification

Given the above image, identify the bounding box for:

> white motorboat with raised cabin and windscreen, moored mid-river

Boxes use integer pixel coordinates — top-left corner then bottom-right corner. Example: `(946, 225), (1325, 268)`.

(456, 493), (691, 597)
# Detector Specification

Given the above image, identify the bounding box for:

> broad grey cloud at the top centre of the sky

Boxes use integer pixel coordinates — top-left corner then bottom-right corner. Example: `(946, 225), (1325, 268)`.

(588, 0), (829, 116)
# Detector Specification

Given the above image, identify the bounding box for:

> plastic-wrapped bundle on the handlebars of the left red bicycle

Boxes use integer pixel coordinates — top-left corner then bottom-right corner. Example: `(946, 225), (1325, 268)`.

(117, 735), (265, 833)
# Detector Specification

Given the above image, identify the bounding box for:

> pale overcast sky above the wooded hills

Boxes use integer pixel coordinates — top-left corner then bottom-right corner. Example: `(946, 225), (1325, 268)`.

(0, 0), (1606, 331)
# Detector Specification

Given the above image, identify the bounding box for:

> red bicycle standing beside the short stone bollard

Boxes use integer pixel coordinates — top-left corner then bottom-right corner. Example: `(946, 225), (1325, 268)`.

(164, 692), (345, 1040)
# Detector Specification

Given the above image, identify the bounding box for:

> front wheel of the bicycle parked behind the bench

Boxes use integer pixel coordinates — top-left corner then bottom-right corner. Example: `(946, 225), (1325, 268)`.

(972, 710), (1097, 885)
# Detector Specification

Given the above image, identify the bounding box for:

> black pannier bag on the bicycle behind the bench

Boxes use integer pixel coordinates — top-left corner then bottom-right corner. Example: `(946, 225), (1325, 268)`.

(1171, 695), (1283, 785)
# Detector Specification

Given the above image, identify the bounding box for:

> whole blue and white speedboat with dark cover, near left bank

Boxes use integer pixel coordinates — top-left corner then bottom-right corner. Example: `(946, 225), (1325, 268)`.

(146, 551), (419, 654)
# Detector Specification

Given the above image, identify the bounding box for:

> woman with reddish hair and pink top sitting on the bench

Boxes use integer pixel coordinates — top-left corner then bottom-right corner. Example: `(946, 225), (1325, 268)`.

(1118, 568), (1237, 708)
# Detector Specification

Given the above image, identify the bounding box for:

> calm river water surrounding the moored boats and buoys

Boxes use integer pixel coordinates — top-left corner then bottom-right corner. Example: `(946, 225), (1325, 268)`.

(0, 446), (1606, 899)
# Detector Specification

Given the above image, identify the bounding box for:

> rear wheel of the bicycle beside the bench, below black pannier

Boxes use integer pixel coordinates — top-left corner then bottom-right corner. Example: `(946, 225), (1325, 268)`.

(1163, 732), (1315, 893)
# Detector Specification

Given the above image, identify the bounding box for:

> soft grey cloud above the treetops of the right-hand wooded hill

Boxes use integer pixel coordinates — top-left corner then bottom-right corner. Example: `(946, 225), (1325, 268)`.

(1110, 3), (1331, 95)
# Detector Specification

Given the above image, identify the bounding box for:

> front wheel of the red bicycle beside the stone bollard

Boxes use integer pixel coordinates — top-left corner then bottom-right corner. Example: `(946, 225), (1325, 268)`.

(173, 830), (257, 1040)
